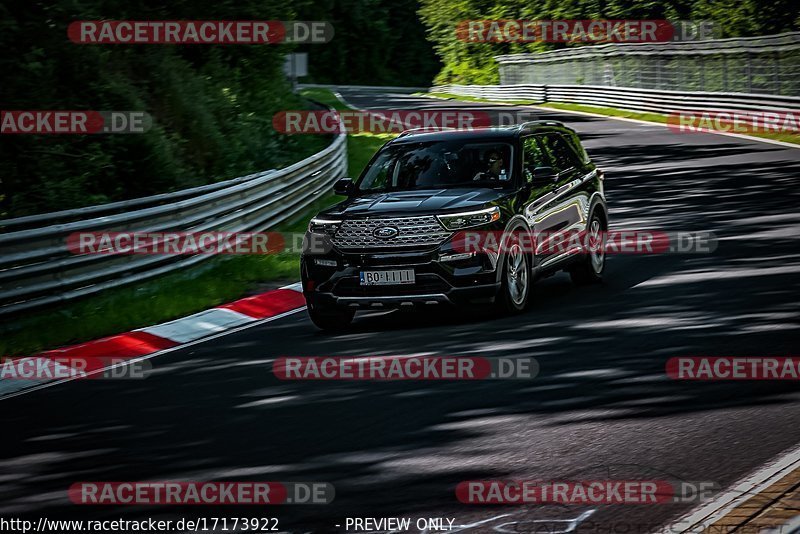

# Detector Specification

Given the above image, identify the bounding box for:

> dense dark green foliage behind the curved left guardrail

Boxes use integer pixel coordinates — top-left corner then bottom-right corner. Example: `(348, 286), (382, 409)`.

(0, 0), (328, 218)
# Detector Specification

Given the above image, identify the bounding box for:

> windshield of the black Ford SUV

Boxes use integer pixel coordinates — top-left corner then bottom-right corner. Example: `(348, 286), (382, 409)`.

(358, 140), (512, 191)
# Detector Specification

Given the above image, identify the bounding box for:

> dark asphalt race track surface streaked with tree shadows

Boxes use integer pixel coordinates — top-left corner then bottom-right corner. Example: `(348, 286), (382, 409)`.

(0, 90), (800, 533)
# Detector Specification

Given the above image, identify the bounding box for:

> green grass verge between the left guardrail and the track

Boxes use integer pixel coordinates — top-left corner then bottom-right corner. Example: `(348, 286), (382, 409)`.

(0, 89), (393, 356)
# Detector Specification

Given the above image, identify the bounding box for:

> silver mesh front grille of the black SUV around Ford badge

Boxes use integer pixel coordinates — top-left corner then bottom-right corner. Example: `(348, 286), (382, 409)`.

(333, 215), (451, 249)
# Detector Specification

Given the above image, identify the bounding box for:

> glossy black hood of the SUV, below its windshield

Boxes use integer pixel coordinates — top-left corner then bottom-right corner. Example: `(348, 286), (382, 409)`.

(325, 188), (512, 217)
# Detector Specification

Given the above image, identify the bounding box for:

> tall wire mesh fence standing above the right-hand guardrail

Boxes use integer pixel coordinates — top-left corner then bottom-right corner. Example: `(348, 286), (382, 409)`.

(495, 32), (800, 96)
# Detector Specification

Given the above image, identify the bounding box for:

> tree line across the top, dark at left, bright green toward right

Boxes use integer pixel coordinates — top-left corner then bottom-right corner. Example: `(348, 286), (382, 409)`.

(0, 0), (800, 218)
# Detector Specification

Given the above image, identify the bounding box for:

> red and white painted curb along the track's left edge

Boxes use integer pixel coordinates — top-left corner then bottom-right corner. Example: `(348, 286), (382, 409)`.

(0, 282), (306, 398)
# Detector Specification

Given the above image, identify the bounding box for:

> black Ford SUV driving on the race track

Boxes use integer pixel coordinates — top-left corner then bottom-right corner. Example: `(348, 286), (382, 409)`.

(301, 121), (608, 329)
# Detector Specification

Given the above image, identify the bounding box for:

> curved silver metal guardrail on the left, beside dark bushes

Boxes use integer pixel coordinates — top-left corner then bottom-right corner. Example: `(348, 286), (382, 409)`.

(0, 134), (347, 316)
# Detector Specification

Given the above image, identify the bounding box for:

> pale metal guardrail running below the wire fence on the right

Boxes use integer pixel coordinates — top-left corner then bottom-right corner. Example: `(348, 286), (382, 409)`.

(430, 84), (800, 114)
